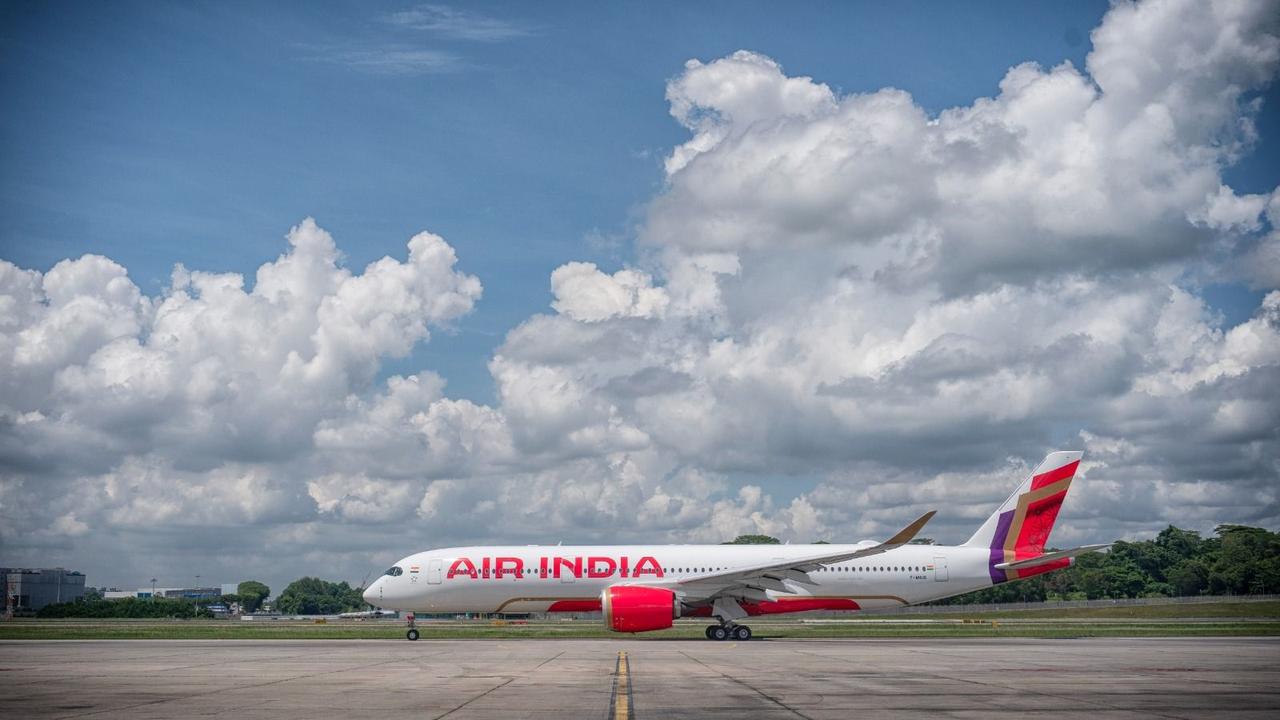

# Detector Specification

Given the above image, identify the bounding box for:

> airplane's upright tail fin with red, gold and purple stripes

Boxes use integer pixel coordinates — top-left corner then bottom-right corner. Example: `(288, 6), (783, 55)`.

(965, 451), (1083, 583)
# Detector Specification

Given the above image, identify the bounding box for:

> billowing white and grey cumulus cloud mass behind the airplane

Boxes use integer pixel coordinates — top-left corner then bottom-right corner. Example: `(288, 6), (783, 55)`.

(0, 0), (1280, 589)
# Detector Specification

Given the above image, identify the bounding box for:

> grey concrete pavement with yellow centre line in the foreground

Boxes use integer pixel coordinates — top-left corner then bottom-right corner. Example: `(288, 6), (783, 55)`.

(0, 638), (1280, 720)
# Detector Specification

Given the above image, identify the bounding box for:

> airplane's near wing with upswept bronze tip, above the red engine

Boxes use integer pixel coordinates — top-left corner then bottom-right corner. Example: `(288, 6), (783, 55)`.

(668, 510), (936, 618)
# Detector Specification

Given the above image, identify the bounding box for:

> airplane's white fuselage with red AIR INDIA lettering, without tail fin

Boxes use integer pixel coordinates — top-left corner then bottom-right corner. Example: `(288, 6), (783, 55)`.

(365, 543), (992, 614)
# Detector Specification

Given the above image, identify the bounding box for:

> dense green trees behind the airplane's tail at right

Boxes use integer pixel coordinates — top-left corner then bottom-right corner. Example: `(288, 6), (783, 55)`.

(940, 525), (1280, 605)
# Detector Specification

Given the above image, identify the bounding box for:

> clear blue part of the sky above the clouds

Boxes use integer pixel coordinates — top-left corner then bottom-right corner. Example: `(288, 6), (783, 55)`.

(0, 3), (1213, 401)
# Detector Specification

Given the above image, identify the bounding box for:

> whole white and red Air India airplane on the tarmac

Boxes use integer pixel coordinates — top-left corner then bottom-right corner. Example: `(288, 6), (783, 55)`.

(364, 451), (1110, 641)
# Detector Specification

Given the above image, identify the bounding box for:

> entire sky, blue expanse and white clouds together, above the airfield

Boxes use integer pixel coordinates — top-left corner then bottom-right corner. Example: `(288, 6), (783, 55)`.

(0, 0), (1280, 584)
